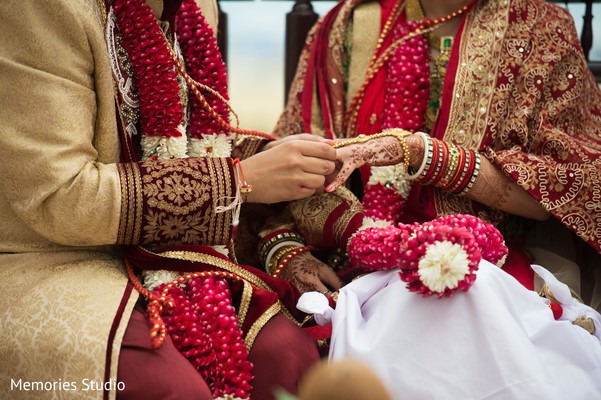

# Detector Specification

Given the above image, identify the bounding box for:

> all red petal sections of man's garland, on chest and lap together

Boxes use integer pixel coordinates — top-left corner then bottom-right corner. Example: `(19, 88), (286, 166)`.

(113, 0), (252, 398)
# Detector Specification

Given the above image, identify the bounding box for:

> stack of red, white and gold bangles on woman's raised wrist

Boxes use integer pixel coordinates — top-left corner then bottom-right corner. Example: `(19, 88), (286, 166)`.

(409, 132), (480, 195)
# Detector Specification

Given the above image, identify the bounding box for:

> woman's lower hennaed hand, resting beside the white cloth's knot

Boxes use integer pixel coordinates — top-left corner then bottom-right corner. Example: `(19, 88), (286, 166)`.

(279, 252), (342, 295)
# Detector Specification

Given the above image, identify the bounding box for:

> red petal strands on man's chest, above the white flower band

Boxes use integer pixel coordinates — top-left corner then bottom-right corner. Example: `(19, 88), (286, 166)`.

(113, 0), (229, 139)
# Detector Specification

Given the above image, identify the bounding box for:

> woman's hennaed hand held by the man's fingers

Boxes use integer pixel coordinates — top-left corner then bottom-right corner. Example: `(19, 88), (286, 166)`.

(326, 136), (404, 192)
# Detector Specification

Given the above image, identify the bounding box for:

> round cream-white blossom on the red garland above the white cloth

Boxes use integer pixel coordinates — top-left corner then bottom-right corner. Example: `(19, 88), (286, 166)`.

(417, 240), (469, 293)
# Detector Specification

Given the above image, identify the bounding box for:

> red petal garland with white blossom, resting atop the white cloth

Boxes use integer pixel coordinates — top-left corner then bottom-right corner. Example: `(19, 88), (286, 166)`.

(348, 215), (507, 298)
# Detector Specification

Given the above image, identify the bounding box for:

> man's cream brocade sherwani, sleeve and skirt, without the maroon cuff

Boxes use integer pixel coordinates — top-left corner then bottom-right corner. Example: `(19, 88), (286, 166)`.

(0, 0), (217, 399)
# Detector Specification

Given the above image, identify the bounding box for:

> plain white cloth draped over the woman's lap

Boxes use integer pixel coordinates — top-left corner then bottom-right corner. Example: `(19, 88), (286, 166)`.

(299, 261), (601, 400)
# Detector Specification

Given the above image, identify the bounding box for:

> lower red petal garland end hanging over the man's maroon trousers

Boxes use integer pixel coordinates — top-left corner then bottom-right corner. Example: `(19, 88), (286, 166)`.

(155, 277), (252, 399)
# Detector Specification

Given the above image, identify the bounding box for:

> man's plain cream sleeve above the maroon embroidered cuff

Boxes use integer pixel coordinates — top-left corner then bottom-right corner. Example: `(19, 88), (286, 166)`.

(0, 0), (121, 245)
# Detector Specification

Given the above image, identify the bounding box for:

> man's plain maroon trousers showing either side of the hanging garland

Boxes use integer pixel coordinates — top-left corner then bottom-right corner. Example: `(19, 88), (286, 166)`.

(117, 307), (319, 400)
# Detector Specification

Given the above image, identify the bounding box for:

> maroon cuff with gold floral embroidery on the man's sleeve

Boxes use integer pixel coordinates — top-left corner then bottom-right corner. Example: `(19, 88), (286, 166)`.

(118, 158), (236, 245)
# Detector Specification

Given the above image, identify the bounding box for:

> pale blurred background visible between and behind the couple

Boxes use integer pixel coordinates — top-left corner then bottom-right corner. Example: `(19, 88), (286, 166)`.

(220, 0), (601, 132)
